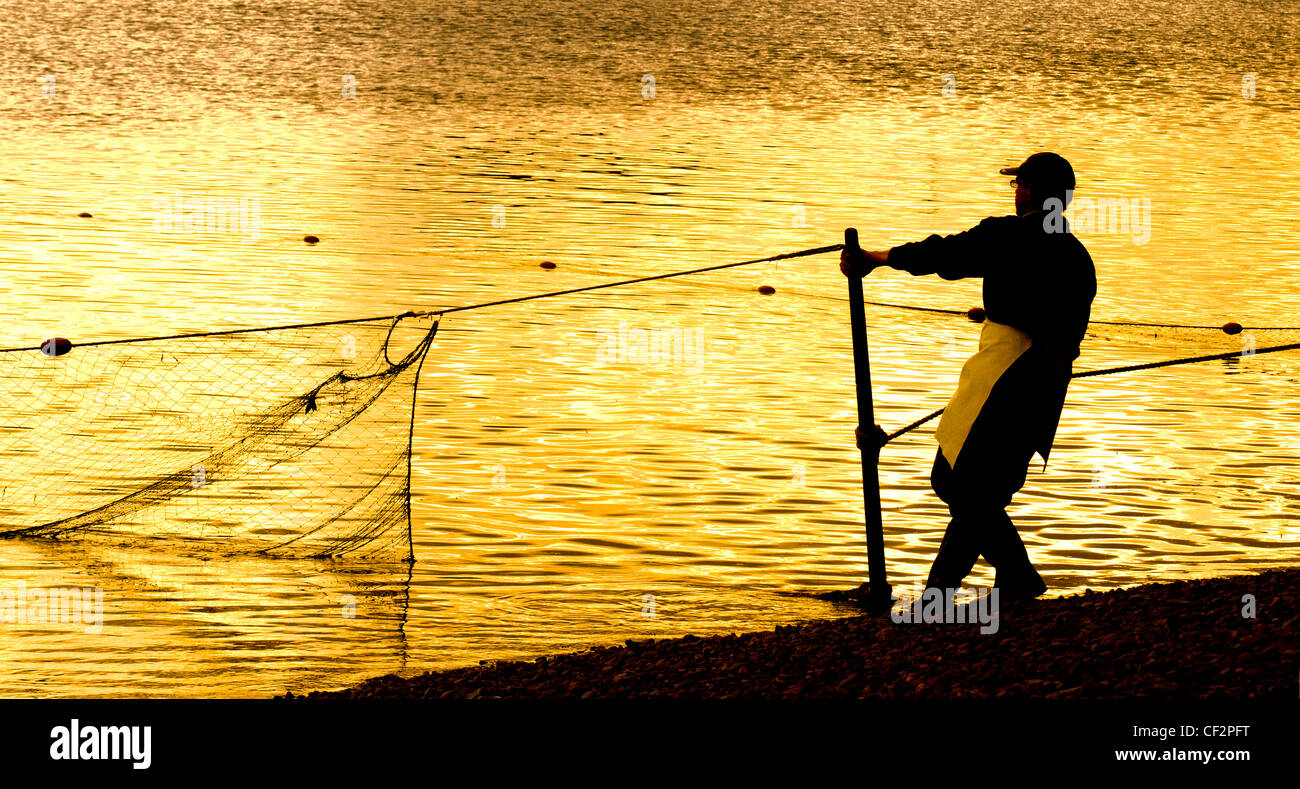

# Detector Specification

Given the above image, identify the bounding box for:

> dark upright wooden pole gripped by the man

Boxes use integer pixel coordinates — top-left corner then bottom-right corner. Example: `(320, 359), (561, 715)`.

(844, 227), (893, 611)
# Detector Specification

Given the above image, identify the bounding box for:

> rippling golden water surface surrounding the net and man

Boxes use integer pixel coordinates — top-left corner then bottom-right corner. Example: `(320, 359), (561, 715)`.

(0, 0), (1300, 697)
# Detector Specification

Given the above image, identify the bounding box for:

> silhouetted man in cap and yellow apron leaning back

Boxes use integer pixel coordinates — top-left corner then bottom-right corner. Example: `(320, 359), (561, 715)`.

(840, 153), (1097, 601)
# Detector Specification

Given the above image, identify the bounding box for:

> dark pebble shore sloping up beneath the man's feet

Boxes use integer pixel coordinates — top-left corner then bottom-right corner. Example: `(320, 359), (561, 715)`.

(287, 568), (1300, 699)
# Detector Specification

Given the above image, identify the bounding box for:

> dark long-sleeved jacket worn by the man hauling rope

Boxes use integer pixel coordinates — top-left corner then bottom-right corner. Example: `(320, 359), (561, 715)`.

(889, 211), (1097, 460)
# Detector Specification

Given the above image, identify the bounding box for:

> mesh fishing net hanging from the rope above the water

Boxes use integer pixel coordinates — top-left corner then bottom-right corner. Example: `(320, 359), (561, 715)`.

(0, 313), (437, 560)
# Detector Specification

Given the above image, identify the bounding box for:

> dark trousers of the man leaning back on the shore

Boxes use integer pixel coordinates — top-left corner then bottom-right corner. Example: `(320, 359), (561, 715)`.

(926, 434), (1045, 597)
